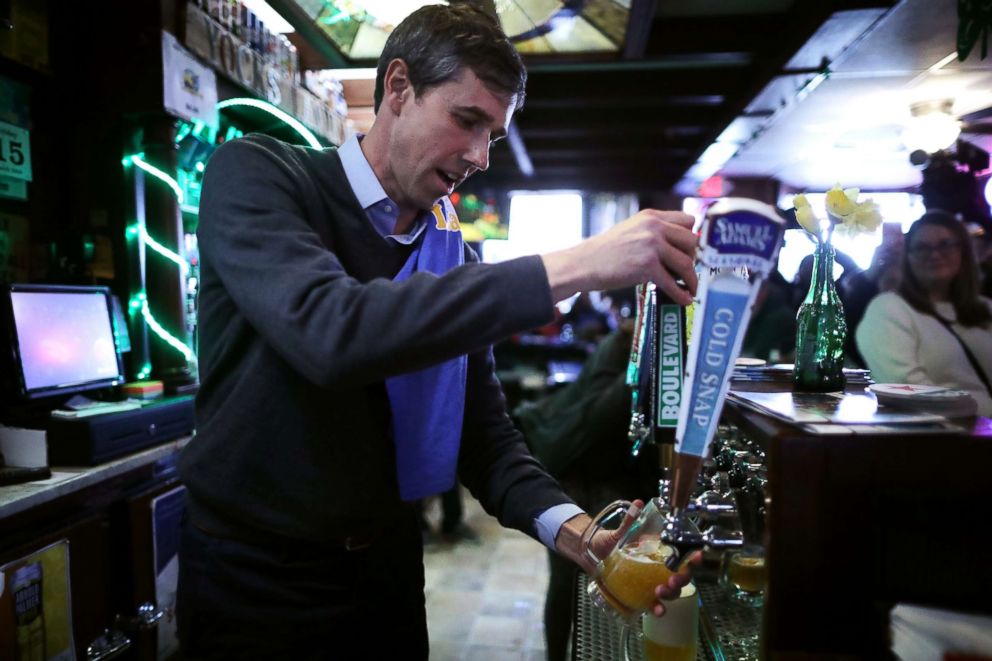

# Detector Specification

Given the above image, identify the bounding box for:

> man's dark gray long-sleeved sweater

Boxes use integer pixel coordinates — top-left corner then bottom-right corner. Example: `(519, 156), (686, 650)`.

(179, 136), (571, 542)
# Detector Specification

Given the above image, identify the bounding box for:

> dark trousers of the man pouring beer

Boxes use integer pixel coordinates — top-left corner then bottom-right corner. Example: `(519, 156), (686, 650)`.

(176, 512), (428, 661)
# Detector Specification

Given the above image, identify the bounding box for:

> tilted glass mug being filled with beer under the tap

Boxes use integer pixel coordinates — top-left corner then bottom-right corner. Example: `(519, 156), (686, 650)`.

(581, 498), (676, 622)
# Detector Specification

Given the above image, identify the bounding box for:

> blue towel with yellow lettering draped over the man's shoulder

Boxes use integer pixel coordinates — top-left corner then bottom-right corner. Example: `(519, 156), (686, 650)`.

(386, 198), (468, 501)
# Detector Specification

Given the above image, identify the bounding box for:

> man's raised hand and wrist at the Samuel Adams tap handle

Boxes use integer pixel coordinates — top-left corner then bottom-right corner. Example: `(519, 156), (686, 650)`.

(541, 209), (697, 305)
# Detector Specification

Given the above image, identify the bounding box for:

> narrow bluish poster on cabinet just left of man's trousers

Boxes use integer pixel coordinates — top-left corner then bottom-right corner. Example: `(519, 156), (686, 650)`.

(151, 487), (186, 659)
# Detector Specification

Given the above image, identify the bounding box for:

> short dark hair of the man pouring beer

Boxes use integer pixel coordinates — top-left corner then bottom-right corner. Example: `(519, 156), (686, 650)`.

(375, 3), (527, 112)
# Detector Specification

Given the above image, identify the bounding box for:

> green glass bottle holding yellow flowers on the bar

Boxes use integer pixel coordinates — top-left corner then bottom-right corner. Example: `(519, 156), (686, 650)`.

(793, 242), (847, 392)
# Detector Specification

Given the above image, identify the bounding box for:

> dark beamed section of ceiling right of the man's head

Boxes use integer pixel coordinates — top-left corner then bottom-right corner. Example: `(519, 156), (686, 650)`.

(474, 0), (895, 191)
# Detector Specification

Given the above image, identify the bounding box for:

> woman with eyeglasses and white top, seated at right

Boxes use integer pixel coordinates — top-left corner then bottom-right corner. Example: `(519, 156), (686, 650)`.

(857, 211), (992, 416)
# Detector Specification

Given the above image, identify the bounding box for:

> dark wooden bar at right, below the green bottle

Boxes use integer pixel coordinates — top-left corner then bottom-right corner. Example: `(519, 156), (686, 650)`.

(573, 384), (992, 659)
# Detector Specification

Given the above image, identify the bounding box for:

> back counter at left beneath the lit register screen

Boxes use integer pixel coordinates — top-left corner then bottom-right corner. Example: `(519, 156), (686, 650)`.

(0, 437), (190, 660)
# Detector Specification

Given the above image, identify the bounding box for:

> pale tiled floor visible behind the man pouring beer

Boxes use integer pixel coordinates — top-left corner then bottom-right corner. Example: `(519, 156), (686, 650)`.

(424, 484), (548, 661)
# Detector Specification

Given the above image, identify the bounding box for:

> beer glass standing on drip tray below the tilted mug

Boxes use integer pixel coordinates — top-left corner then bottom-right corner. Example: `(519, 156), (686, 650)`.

(620, 583), (699, 661)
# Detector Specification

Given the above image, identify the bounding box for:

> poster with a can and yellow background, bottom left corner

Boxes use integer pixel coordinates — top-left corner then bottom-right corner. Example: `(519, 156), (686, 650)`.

(0, 539), (76, 661)
